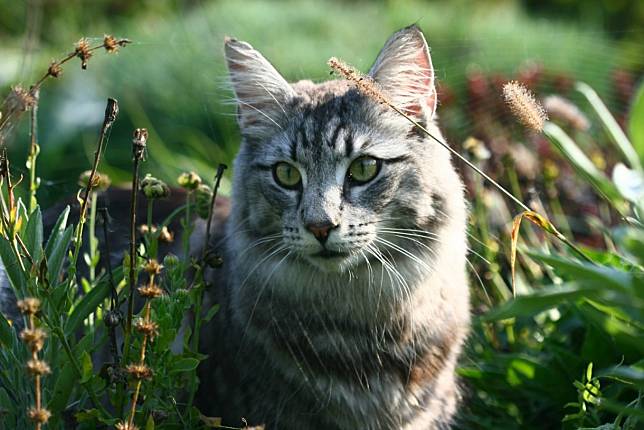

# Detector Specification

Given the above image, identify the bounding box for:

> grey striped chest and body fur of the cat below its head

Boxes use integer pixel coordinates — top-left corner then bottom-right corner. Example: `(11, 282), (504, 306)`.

(200, 191), (469, 429)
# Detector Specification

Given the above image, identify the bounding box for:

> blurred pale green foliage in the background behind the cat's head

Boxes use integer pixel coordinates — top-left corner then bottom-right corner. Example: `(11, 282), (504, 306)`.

(0, 0), (644, 202)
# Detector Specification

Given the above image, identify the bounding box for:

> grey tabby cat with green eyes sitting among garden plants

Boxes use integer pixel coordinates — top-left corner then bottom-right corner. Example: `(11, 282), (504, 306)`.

(198, 26), (470, 430)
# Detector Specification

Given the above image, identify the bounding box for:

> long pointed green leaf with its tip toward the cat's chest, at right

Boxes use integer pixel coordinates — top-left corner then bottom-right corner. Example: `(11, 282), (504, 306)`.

(482, 282), (593, 321)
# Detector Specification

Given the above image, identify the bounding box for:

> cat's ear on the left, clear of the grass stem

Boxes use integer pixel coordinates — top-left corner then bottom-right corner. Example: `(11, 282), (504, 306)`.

(224, 37), (295, 138)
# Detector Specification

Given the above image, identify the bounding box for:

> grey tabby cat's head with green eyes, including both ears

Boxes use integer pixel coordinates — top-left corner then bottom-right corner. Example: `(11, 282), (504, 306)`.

(225, 26), (462, 272)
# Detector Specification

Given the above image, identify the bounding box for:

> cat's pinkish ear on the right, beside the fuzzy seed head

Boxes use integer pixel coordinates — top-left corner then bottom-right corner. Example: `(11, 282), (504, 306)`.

(369, 25), (437, 119)
